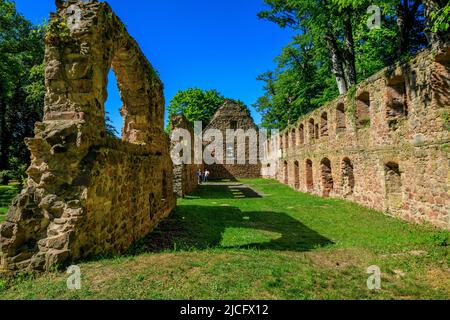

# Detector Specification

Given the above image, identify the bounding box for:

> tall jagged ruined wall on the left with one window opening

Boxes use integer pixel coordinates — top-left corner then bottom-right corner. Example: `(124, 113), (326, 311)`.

(0, 1), (175, 270)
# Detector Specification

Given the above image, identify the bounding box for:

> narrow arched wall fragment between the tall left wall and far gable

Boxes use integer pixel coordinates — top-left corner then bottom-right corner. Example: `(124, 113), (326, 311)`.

(171, 115), (203, 198)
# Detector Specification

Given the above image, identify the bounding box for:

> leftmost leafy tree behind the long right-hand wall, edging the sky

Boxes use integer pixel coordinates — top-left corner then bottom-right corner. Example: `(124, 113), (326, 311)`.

(254, 35), (337, 129)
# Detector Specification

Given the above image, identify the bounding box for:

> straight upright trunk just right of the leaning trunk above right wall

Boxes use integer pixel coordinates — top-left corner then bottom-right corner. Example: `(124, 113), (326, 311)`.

(343, 12), (356, 88)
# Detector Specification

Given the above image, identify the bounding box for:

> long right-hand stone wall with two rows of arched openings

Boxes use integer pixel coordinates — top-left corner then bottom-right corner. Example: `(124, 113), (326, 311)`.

(262, 47), (450, 229)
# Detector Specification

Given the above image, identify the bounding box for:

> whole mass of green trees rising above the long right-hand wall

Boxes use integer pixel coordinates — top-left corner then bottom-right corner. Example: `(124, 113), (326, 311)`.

(254, 0), (450, 129)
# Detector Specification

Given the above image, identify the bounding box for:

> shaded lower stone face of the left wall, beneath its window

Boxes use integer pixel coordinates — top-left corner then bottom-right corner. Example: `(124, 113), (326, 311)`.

(70, 148), (175, 259)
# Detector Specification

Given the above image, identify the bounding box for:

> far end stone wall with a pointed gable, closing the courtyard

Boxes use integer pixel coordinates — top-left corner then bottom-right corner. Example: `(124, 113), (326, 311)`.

(204, 100), (261, 180)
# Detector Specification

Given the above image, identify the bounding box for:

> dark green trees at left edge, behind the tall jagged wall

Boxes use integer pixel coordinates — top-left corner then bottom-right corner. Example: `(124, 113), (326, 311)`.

(0, 0), (45, 179)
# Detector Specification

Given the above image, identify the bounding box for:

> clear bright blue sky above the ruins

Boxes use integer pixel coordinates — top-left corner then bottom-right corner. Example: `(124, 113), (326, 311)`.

(16, 0), (293, 132)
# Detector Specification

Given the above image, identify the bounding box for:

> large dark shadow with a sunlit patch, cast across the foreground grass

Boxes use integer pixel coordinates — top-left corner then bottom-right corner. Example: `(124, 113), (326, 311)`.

(129, 205), (333, 254)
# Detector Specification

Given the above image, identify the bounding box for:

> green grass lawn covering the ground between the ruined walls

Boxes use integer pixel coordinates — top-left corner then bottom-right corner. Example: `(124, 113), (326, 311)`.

(0, 179), (450, 300)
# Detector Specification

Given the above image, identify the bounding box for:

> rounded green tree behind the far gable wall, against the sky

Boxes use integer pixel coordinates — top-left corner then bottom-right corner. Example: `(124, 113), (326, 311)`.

(168, 88), (243, 128)
